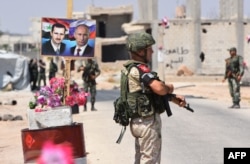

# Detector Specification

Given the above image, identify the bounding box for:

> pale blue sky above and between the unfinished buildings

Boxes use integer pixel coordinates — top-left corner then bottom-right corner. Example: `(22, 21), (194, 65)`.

(0, 0), (250, 34)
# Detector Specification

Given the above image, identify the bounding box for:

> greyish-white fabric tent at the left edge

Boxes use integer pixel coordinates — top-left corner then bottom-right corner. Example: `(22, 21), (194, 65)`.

(0, 52), (30, 90)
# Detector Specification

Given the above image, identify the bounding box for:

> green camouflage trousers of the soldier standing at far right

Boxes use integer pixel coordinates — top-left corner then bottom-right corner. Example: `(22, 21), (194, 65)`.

(228, 78), (240, 104)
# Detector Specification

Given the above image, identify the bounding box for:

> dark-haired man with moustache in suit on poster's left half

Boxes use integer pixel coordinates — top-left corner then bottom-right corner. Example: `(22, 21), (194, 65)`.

(42, 23), (66, 55)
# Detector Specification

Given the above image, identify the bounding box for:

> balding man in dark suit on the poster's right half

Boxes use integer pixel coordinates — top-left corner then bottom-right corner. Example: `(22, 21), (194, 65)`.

(70, 24), (94, 57)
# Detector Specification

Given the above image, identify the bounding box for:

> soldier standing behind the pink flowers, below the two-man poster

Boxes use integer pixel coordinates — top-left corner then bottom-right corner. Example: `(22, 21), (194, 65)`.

(77, 58), (101, 111)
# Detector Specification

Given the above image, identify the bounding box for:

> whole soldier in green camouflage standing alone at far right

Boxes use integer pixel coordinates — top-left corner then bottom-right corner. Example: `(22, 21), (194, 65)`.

(222, 47), (244, 109)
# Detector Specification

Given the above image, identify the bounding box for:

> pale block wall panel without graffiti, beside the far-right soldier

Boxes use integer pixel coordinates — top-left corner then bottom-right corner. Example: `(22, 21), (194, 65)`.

(201, 22), (237, 74)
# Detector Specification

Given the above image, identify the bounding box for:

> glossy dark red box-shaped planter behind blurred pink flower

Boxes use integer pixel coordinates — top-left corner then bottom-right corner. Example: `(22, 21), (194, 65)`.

(21, 123), (87, 164)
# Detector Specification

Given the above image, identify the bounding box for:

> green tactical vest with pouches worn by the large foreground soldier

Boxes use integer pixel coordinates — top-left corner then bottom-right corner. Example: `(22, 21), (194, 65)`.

(113, 61), (165, 143)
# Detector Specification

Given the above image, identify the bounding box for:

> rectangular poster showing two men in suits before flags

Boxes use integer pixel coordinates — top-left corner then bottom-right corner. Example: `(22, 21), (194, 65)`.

(41, 18), (96, 57)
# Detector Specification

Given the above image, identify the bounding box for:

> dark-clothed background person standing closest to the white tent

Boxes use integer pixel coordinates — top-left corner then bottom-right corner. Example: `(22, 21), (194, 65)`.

(29, 58), (38, 91)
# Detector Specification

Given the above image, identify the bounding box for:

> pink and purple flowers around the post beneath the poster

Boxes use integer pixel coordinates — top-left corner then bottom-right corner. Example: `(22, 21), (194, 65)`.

(29, 78), (89, 111)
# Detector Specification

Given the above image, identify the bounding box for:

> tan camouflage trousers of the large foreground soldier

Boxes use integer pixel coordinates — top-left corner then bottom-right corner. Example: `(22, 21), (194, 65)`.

(130, 114), (162, 164)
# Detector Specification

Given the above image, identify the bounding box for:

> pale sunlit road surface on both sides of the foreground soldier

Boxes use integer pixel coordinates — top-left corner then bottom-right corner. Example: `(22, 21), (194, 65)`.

(73, 91), (250, 164)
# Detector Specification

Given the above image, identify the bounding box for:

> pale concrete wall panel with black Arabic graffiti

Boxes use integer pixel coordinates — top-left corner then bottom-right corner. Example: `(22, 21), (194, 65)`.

(163, 21), (196, 73)
